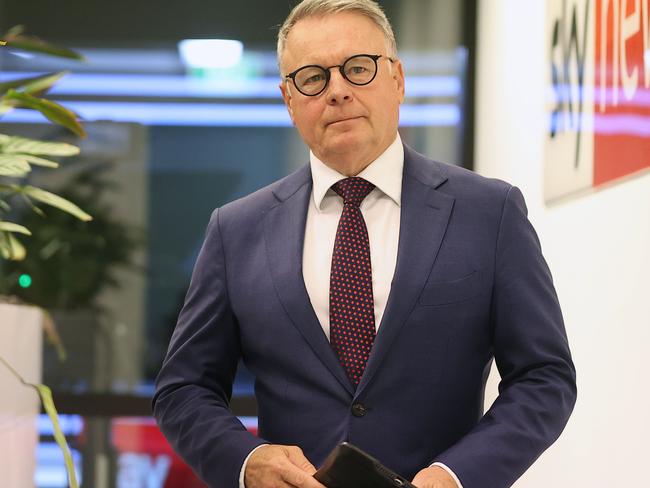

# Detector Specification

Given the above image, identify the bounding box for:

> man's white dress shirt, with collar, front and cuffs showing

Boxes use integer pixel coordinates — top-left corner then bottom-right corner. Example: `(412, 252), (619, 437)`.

(239, 134), (462, 488)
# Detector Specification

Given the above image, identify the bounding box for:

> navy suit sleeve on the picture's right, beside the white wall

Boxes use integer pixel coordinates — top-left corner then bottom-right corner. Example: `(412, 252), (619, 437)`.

(436, 187), (576, 488)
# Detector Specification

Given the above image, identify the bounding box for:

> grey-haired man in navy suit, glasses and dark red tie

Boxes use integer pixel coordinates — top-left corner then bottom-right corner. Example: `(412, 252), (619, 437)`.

(154, 0), (576, 488)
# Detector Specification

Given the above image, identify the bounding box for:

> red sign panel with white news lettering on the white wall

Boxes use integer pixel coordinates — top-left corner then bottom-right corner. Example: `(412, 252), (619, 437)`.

(593, 0), (650, 186)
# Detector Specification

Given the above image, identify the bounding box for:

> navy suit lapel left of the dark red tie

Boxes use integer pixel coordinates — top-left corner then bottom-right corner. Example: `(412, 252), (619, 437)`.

(264, 166), (353, 395)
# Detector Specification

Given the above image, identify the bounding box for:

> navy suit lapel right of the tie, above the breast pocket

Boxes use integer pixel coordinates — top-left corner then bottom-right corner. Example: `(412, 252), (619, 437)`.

(356, 146), (454, 395)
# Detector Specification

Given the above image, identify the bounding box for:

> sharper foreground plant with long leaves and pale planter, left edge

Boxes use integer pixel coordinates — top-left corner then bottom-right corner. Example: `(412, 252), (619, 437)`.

(0, 26), (92, 487)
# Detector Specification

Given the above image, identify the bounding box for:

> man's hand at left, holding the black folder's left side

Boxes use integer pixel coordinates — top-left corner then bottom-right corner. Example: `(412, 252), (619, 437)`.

(244, 444), (325, 488)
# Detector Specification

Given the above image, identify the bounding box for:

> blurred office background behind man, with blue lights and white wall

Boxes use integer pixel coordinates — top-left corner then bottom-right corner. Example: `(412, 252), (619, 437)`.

(0, 0), (650, 488)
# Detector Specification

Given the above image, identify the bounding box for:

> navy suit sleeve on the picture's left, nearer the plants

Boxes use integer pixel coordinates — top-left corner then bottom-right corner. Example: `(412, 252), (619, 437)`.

(153, 210), (265, 488)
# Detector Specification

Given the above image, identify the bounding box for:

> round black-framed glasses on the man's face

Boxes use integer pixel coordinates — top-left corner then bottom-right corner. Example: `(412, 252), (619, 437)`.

(285, 54), (394, 97)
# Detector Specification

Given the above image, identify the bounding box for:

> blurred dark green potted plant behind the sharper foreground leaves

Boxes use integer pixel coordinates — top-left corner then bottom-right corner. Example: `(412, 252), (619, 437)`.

(0, 160), (143, 392)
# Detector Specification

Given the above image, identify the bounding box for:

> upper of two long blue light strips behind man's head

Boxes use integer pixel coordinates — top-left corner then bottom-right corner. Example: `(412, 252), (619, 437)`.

(0, 72), (461, 99)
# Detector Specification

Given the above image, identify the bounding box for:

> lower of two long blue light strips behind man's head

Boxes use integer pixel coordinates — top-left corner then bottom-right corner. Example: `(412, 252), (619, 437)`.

(0, 101), (460, 127)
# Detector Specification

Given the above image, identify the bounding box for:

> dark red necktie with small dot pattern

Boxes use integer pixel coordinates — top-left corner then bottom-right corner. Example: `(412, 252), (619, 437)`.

(330, 177), (375, 386)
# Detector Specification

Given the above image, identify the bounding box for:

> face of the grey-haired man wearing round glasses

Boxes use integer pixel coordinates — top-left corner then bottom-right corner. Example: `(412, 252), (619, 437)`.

(280, 12), (404, 174)
